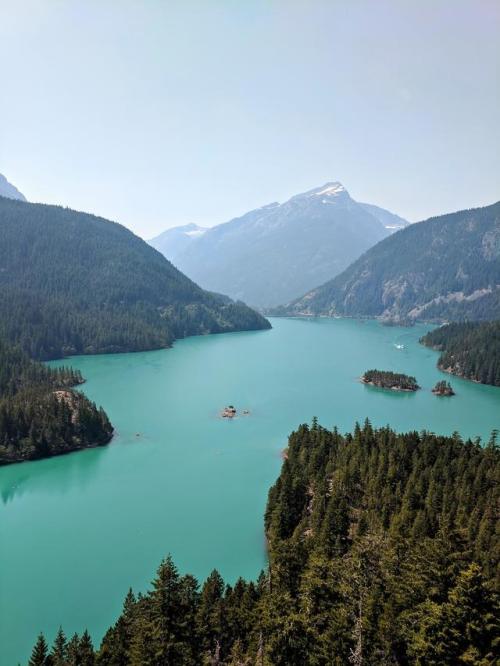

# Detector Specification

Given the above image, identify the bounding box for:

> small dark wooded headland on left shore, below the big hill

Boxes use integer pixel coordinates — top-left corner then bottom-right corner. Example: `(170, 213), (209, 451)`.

(0, 341), (113, 465)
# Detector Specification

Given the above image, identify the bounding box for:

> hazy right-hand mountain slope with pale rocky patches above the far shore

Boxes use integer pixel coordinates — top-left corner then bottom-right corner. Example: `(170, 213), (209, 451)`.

(277, 202), (500, 321)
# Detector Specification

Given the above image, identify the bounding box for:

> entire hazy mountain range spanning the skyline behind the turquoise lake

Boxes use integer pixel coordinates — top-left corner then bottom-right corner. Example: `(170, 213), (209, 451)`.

(4, 170), (500, 328)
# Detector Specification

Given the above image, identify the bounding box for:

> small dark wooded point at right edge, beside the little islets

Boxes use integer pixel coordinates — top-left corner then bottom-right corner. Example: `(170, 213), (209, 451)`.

(421, 321), (500, 386)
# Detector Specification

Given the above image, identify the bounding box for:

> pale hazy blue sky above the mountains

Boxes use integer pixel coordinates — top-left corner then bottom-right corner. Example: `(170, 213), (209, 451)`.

(0, 0), (500, 238)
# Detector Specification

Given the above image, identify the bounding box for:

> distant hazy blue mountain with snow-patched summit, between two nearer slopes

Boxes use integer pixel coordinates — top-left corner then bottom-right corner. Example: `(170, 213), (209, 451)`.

(152, 182), (399, 307)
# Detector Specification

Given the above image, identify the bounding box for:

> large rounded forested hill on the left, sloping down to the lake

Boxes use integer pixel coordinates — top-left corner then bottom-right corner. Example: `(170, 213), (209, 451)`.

(0, 198), (270, 359)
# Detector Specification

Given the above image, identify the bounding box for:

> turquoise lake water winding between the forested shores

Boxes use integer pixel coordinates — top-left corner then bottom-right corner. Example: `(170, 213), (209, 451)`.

(0, 319), (500, 666)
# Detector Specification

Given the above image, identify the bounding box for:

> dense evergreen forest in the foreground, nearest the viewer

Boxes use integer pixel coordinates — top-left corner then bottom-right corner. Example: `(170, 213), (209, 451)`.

(30, 421), (500, 666)
